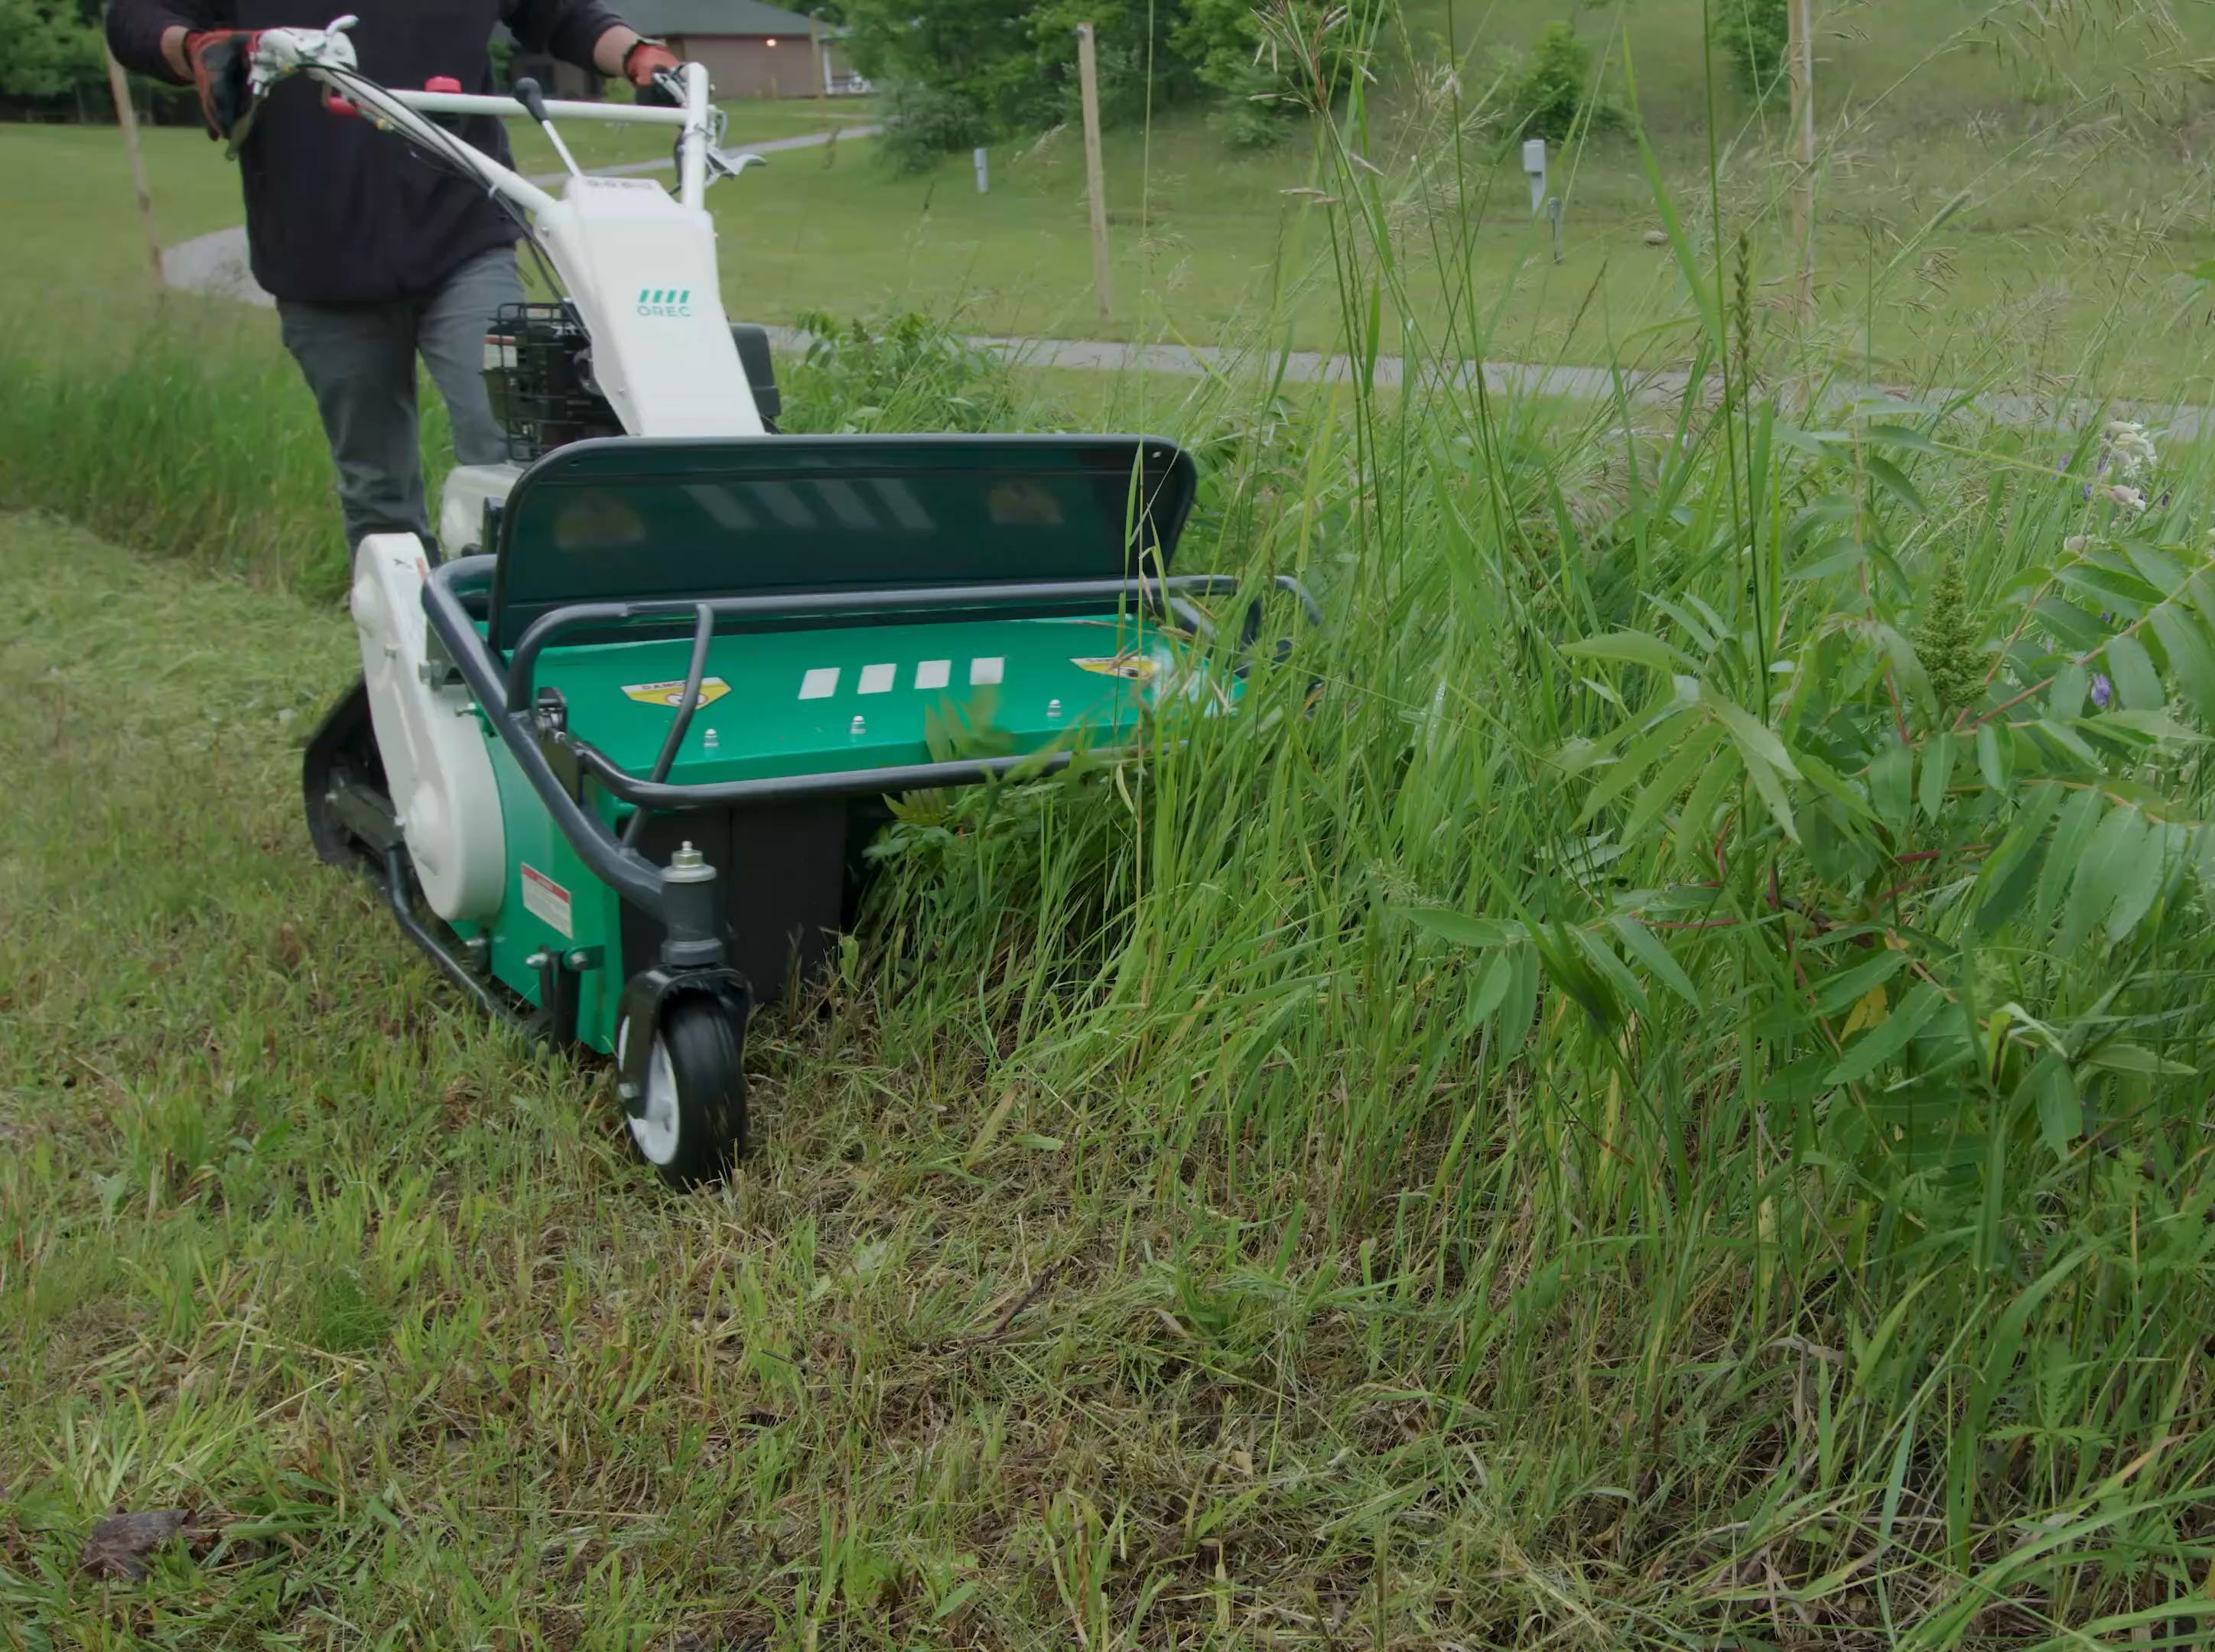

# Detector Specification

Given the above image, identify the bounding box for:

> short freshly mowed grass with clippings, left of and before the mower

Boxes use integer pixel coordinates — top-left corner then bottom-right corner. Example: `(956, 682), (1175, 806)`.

(0, 505), (1783, 1647)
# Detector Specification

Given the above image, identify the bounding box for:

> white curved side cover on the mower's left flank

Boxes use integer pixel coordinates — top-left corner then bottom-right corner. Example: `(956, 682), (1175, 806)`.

(348, 534), (507, 923)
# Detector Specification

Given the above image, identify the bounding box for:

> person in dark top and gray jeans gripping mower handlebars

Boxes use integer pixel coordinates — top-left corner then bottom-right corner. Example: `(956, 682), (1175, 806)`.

(106, 0), (678, 549)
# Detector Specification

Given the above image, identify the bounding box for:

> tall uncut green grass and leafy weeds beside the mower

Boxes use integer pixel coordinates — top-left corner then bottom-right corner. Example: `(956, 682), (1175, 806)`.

(0, 9), (2215, 1647)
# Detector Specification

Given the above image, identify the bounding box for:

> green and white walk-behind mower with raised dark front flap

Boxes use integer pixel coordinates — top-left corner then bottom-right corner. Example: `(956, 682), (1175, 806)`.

(277, 18), (1313, 1187)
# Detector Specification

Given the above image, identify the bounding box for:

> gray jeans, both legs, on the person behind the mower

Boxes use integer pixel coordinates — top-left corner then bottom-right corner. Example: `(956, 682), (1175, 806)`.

(277, 246), (522, 549)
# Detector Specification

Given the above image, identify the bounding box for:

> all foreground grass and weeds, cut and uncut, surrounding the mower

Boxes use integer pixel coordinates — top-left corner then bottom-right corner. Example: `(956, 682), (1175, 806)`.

(0, 6), (2215, 1652)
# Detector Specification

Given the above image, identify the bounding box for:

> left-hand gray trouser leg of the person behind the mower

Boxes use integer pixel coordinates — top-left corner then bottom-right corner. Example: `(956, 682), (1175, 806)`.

(277, 299), (430, 549)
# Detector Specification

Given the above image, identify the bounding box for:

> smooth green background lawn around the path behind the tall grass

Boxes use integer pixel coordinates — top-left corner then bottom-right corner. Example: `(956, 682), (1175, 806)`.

(17, 0), (2215, 398)
